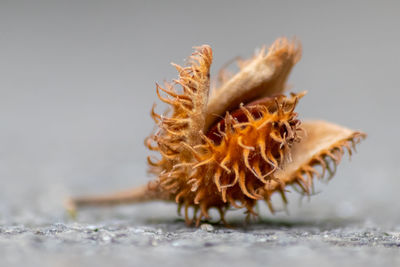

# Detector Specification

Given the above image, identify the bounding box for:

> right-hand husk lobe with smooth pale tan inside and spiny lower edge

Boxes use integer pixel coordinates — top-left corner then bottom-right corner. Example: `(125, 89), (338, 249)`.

(271, 121), (366, 194)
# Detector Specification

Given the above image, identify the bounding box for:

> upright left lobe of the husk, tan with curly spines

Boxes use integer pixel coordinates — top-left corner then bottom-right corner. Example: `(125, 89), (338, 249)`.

(146, 46), (212, 201)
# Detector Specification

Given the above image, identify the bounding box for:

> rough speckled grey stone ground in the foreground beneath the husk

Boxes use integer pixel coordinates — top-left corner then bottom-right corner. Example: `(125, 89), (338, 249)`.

(0, 204), (400, 266)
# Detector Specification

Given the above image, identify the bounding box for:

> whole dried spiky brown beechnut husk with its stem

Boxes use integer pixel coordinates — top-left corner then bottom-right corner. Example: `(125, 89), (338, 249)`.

(68, 38), (365, 225)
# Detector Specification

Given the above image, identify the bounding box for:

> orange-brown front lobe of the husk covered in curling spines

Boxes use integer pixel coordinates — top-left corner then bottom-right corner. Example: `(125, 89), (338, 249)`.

(181, 95), (301, 217)
